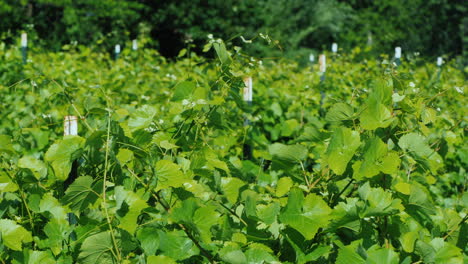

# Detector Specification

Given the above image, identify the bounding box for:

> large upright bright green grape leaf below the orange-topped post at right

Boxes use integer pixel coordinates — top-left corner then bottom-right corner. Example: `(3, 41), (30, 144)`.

(323, 127), (361, 175)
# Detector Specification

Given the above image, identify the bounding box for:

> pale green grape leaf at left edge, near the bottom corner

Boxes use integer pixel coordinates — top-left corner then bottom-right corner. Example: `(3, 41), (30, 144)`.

(0, 219), (32, 250)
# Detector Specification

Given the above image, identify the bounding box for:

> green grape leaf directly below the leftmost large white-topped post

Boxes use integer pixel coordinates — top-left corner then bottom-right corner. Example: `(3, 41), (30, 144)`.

(45, 136), (85, 181)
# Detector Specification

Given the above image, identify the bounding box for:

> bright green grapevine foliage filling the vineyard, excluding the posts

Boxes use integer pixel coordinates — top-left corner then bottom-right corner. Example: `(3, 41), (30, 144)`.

(0, 39), (468, 264)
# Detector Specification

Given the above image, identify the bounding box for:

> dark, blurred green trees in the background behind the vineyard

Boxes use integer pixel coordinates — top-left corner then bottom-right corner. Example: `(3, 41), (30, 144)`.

(0, 0), (468, 57)
